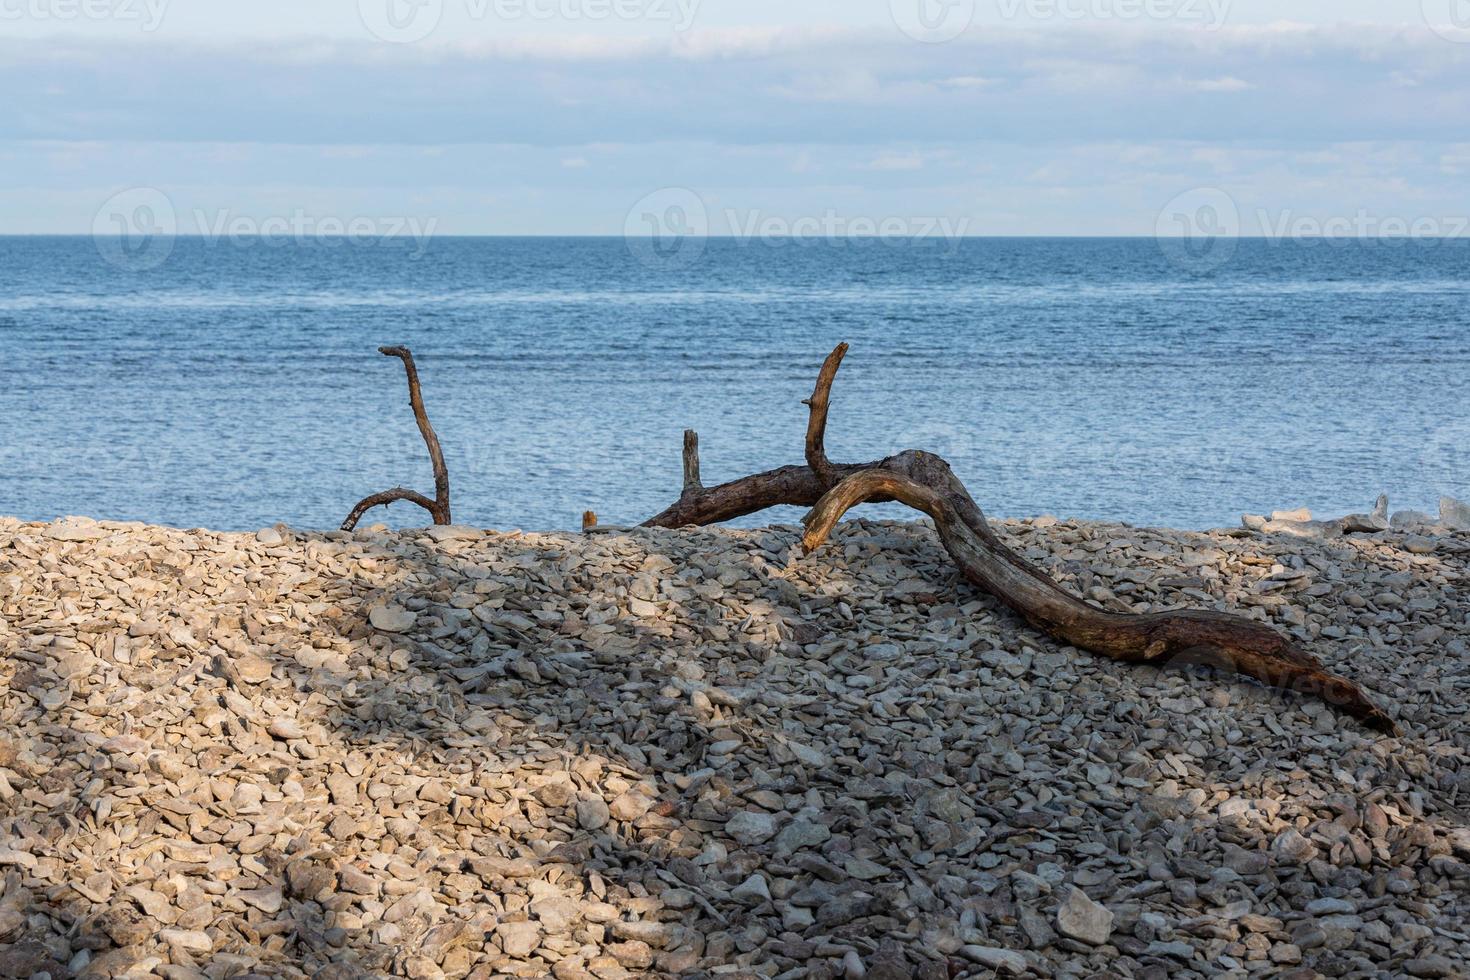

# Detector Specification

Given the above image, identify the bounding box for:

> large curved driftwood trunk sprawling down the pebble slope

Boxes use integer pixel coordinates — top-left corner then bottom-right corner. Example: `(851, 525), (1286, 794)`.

(645, 344), (1397, 732)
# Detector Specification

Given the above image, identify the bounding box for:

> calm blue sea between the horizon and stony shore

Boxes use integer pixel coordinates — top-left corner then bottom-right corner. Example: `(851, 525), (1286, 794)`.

(0, 238), (1470, 529)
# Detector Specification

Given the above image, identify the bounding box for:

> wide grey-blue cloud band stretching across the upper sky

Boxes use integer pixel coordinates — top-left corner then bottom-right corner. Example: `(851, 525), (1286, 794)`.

(0, 25), (1470, 145)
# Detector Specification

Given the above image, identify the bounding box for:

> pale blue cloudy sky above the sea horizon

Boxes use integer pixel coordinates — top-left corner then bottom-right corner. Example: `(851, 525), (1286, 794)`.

(0, 0), (1470, 237)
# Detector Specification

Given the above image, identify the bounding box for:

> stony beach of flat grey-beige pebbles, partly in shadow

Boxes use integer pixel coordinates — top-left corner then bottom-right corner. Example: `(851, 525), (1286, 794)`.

(0, 507), (1470, 980)
